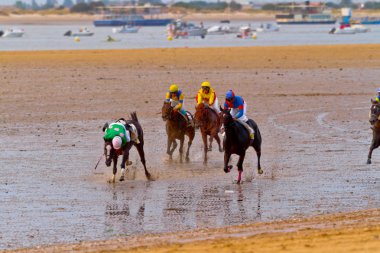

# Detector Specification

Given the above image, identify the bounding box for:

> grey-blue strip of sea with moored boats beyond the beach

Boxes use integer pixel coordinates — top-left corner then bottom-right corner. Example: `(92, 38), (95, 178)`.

(0, 20), (380, 51)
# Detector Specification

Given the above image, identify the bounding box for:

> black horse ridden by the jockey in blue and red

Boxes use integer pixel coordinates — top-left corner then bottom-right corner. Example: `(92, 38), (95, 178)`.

(220, 108), (263, 184)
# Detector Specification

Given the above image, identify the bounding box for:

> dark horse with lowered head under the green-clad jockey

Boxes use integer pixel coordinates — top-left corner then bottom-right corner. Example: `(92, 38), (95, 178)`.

(103, 112), (151, 183)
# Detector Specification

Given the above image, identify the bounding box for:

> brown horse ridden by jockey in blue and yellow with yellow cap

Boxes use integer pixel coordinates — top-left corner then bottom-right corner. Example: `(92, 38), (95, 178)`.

(162, 101), (195, 162)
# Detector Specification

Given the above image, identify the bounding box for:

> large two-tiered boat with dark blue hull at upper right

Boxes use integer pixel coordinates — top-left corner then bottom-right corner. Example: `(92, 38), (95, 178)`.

(275, 1), (336, 25)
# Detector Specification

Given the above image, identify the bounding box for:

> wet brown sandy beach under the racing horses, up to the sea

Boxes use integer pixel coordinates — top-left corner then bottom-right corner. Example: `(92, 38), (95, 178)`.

(0, 45), (380, 252)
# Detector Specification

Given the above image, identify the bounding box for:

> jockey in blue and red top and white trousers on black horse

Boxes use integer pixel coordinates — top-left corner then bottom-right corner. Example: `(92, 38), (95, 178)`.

(224, 90), (255, 139)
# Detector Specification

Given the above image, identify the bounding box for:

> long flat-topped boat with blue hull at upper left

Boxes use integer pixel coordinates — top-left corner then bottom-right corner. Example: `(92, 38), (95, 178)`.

(94, 4), (173, 26)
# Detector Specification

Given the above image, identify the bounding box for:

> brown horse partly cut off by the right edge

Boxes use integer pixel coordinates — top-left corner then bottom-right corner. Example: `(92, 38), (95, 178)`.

(367, 99), (380, 164)
